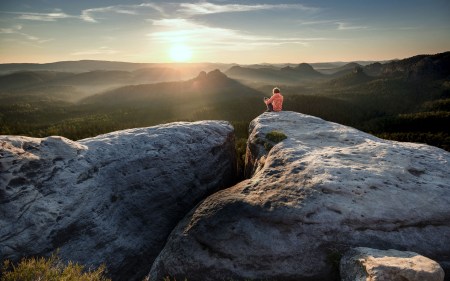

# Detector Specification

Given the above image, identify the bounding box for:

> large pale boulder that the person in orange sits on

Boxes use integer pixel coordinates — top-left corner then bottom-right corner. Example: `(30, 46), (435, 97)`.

(150, 112), (450, 281)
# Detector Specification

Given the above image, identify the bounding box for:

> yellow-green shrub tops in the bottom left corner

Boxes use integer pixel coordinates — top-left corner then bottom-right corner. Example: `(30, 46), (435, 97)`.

(1, 254), (110, 281)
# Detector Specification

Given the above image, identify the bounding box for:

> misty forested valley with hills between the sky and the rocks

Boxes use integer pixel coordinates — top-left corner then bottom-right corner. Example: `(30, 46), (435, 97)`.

(0, 52), (450, 151)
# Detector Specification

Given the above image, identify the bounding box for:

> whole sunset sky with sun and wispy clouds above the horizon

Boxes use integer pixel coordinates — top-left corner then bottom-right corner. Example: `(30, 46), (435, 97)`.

(0, 0), (450, 64)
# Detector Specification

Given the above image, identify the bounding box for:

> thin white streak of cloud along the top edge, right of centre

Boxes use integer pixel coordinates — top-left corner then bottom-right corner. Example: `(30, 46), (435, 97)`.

(179, 2), (319, 16)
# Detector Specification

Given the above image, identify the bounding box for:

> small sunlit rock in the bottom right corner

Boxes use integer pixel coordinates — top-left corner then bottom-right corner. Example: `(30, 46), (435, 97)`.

(340, 247), (444, 281)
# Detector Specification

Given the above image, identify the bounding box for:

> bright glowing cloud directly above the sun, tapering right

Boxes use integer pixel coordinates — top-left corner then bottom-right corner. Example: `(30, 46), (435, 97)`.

(147, 19), (327, 50)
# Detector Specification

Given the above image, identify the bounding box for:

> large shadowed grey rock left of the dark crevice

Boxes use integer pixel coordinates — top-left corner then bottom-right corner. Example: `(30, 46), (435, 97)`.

(0, 121), (236, 280)
